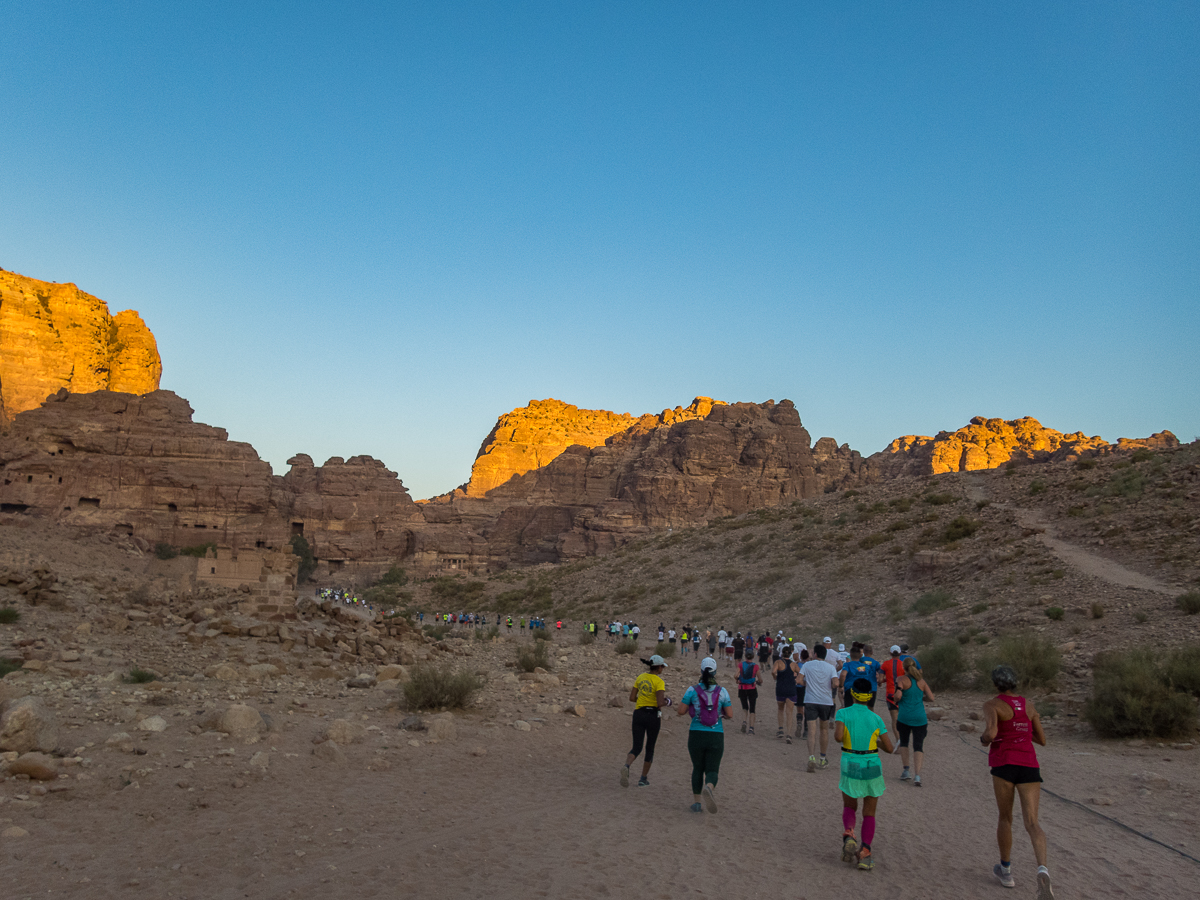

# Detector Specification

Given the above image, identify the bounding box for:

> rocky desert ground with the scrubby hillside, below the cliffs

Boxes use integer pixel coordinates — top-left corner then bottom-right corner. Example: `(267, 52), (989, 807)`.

(0, 445), (1200, 898)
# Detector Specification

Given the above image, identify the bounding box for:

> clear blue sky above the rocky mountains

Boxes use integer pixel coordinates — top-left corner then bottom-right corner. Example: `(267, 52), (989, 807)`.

(0, 0), (1200, 498)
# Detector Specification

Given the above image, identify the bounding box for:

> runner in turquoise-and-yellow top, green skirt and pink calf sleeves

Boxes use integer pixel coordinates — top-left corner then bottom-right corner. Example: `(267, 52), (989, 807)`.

(835, 681), (892, 871)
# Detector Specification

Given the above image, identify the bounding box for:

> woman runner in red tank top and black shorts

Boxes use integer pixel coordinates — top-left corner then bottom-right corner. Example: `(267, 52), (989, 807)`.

(979, 666), (1054, 900)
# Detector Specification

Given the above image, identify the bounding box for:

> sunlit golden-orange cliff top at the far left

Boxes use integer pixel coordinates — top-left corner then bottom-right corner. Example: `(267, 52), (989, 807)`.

(0, 270), (162, 427)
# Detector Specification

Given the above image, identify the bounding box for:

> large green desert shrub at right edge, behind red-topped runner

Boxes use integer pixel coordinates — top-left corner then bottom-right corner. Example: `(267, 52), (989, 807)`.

(1084, 648), (1196, 738)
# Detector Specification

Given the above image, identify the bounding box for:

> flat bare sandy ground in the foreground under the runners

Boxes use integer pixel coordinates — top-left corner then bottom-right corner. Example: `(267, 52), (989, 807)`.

(0, 666), (1200, 900)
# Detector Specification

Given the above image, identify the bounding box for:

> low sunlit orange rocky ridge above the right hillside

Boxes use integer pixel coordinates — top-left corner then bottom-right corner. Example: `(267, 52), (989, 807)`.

(868, 415), (1180, 478)
